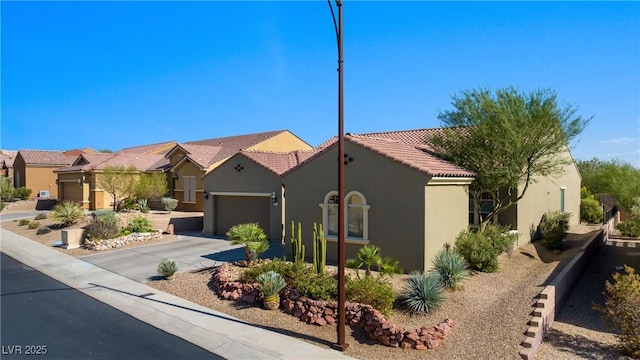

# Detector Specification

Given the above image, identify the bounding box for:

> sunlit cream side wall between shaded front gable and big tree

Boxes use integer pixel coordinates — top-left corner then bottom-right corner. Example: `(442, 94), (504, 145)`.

(424, 183), (469, 270)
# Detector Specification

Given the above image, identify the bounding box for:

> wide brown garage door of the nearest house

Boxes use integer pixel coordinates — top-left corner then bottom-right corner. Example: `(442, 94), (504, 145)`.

(215, 196), (271, 236)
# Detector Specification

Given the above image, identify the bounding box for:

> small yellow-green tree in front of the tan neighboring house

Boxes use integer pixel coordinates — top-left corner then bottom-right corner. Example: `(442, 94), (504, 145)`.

(96, 165), (140, 211)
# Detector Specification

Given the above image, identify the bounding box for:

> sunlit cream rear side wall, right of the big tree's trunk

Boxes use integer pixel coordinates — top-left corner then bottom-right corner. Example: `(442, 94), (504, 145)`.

(512, 151), (581, 246)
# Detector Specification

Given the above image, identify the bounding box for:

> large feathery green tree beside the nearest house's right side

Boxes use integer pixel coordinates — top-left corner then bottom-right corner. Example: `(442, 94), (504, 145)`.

(426, 88), (590, 230)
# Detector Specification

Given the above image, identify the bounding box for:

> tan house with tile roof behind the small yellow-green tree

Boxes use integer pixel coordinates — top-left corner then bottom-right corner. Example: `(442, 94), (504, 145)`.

(55, 152), (168, 210)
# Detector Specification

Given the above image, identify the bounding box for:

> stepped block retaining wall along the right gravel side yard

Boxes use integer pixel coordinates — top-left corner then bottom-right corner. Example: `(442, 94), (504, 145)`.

(519, 225), (609, 360)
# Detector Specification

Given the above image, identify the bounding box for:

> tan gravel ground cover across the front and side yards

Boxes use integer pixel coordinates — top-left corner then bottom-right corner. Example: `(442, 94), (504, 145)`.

(2, 202), (623, 360)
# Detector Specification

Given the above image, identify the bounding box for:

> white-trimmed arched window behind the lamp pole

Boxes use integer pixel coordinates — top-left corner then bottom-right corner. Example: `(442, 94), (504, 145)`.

(320, 191), (370, 243)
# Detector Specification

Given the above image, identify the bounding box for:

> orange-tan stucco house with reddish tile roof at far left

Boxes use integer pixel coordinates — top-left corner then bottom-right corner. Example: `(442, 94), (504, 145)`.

(13, 150), (76, 199)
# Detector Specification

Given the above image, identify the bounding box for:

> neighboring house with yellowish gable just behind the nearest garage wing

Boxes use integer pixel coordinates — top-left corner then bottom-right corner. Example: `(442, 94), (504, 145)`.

(165, 130), (311, 211)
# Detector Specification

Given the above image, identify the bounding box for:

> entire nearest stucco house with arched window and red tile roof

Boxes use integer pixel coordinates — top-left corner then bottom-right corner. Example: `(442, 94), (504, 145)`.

(203, 129), (580, 270)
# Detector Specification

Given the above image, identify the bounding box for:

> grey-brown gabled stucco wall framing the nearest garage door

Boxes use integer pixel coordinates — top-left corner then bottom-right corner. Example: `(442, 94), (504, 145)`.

(202, 155), (283, 242)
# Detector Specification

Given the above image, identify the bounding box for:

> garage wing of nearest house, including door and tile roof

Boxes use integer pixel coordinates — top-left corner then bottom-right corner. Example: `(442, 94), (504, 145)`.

(202, 150), (315, 242)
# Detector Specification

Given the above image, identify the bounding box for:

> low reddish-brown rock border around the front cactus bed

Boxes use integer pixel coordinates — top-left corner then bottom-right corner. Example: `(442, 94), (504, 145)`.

(213, 263), (455, 350)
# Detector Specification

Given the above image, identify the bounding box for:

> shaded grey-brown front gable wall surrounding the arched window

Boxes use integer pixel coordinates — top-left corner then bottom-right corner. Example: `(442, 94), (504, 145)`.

(283, 142), (440, 271)
